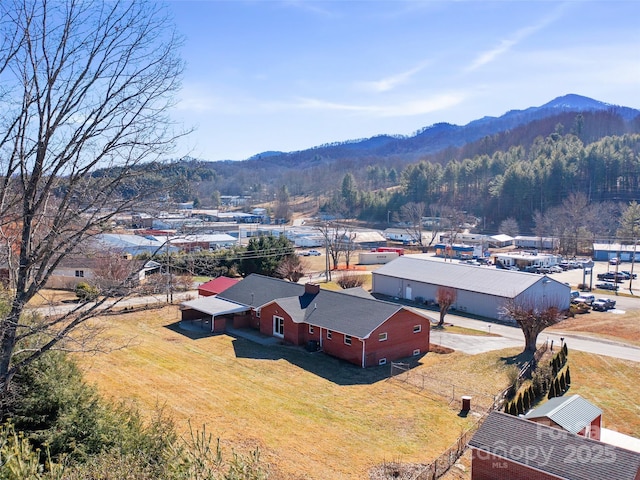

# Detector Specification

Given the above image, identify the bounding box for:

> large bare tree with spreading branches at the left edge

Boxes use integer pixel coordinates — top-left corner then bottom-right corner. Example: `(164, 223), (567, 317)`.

(0, 0), (189, 388)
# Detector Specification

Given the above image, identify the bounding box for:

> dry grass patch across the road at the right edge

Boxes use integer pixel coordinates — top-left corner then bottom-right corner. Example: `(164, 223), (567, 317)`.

(549, 310), (640, 345)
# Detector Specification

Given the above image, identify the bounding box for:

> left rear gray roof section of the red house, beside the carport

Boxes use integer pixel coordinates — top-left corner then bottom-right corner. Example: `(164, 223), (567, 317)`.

(218, 273), (304, 307)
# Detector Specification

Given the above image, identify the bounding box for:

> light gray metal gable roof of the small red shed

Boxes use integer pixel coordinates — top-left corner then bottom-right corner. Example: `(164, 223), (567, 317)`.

(524, 395), (602, 433)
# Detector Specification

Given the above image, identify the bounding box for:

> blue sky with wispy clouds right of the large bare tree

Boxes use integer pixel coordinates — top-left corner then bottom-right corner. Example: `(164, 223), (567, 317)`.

(169, 0), (640, 160)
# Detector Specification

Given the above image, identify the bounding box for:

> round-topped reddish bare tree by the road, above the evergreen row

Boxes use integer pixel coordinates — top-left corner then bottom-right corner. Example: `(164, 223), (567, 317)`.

(502, 298), (563, 352)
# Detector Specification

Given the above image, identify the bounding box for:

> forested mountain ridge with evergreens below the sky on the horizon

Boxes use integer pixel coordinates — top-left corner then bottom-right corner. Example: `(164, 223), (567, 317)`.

(116, 95), (640, 230)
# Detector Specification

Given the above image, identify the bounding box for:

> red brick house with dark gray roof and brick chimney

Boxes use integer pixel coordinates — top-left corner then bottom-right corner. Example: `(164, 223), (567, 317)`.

(183, 275), (432, 368)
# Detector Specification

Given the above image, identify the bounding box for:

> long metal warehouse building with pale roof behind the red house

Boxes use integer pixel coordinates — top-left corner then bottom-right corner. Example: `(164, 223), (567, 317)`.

(372, 255), (571, 319)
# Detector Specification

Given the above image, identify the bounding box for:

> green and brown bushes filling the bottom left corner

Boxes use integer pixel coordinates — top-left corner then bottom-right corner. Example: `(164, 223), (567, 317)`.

(0, 352), (268, 480)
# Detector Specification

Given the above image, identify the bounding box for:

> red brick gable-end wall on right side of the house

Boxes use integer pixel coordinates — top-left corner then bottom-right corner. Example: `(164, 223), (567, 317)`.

(365, 310), (431, 367)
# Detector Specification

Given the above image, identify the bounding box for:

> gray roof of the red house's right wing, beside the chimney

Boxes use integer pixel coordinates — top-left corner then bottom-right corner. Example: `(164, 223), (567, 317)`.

(274, 290), (431, 338)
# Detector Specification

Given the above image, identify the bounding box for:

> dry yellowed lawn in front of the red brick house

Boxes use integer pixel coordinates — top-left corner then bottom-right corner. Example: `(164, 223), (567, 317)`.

(74, 308), (473, 480)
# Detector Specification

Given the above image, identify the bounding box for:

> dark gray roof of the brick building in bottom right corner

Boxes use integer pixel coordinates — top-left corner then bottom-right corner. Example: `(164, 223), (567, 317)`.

(469, 411), (640, 480)
